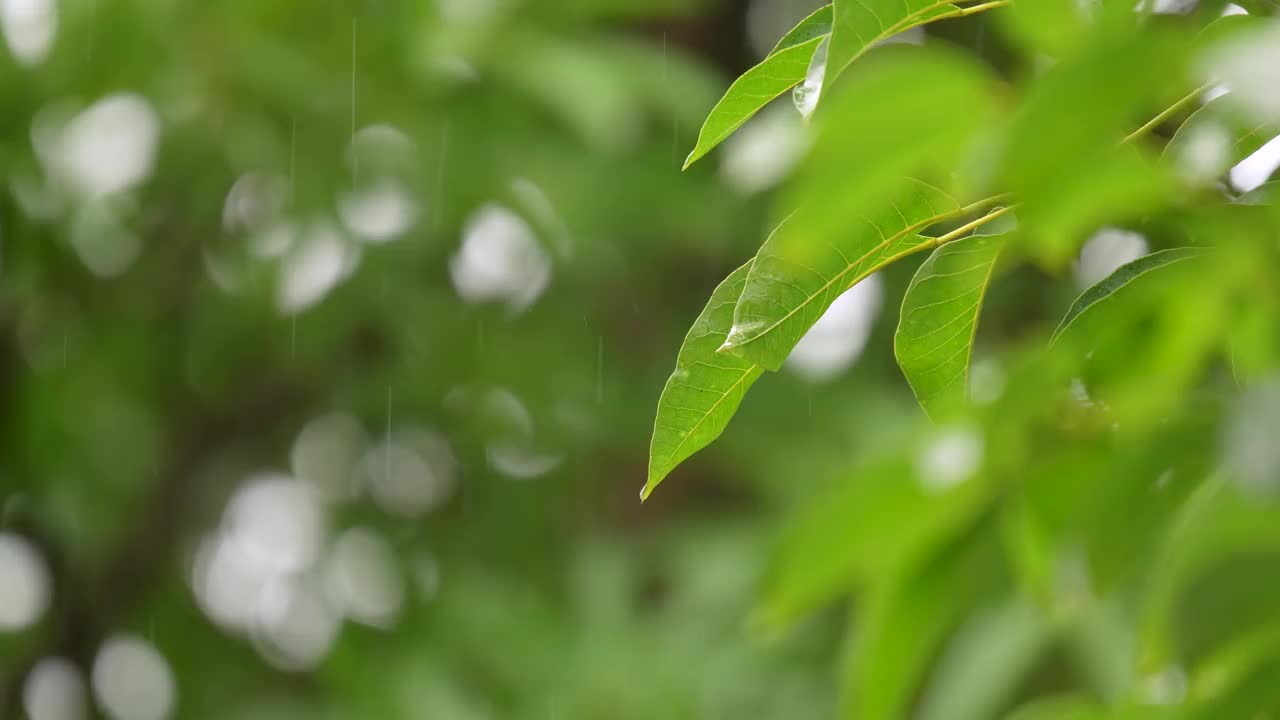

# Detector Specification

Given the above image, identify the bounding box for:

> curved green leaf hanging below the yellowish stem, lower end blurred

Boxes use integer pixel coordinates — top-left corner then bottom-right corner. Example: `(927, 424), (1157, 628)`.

(893, 236), (1005, 413)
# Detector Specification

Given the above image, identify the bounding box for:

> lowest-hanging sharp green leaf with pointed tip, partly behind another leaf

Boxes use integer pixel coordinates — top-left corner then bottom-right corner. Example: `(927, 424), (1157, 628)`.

(640, 263), (763, 498)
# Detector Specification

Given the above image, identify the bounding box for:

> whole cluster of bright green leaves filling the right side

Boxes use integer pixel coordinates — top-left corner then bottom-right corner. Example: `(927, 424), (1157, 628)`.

(643, 0), (1280, 720)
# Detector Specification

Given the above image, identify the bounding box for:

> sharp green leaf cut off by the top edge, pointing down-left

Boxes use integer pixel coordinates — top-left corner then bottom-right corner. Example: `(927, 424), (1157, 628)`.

(822, 0), (959, 95)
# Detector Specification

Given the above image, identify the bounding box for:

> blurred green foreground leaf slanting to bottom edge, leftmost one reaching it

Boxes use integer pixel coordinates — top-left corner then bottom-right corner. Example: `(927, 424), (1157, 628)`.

(842, 527), (1000, 720)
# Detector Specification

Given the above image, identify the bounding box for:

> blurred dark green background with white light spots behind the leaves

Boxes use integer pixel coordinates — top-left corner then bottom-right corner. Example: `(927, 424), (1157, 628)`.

(0, 0), (1275, 720)
